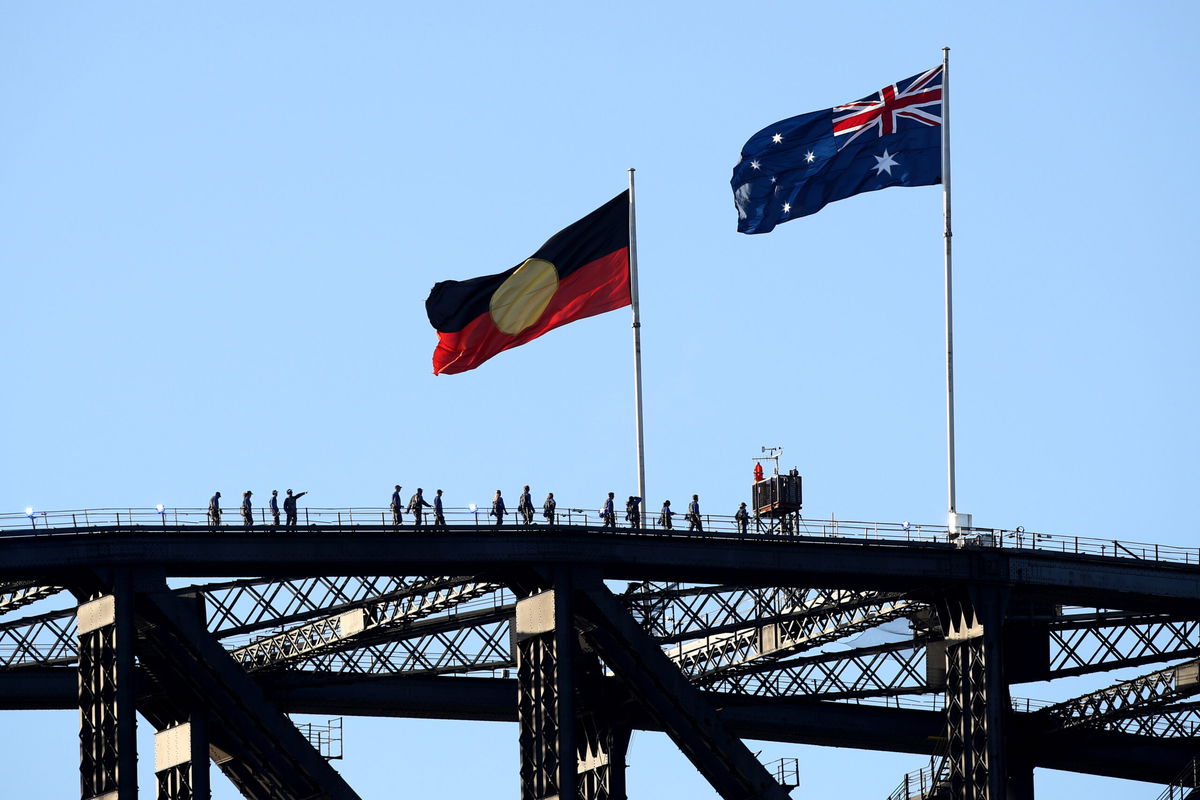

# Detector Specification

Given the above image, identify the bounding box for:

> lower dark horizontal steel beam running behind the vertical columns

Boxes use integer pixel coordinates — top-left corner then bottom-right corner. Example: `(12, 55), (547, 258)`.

(0, 667), (1195, 784)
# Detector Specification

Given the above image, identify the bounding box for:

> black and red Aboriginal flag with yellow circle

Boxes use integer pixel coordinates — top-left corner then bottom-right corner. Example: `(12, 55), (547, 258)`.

(425, 192), (630, 374)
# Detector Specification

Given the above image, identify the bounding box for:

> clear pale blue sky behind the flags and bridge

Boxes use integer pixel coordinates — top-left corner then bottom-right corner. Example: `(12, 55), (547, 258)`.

(0, 0), (1200, 800)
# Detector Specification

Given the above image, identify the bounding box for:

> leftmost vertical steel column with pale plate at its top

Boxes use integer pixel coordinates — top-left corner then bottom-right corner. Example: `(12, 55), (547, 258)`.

(76, 573), (138, 800)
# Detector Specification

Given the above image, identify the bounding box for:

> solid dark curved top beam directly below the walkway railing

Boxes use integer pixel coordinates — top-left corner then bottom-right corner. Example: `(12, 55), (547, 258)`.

(9, 525), (1200, 613)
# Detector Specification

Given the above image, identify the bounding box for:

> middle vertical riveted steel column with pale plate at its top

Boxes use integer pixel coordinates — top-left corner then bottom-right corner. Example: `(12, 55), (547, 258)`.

(514, 578), (578, 800)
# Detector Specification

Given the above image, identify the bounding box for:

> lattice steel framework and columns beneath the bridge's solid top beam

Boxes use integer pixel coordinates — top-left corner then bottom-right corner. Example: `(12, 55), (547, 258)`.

(0, 525), (1200, 800)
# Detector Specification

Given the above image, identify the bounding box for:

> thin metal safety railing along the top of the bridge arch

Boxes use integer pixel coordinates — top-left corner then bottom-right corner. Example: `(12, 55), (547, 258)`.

(0, 505), (1200, 565)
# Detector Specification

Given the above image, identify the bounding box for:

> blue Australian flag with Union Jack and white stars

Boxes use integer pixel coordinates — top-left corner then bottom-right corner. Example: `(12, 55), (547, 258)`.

(731, 65), (942, 234)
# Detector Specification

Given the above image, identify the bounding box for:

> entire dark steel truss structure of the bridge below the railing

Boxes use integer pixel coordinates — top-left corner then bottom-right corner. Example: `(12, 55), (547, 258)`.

(0, 525), (1200, 800)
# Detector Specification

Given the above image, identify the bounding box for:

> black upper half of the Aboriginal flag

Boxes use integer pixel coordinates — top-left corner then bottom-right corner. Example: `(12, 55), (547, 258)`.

(425, 191), (629, 332)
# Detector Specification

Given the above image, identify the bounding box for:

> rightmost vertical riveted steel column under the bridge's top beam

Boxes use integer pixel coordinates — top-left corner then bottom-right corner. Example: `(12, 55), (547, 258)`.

(940, 589), (1012, 800)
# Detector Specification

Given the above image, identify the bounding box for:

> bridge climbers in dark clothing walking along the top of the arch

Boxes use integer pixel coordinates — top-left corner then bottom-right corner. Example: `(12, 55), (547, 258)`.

(209, 483), (750, 534)
